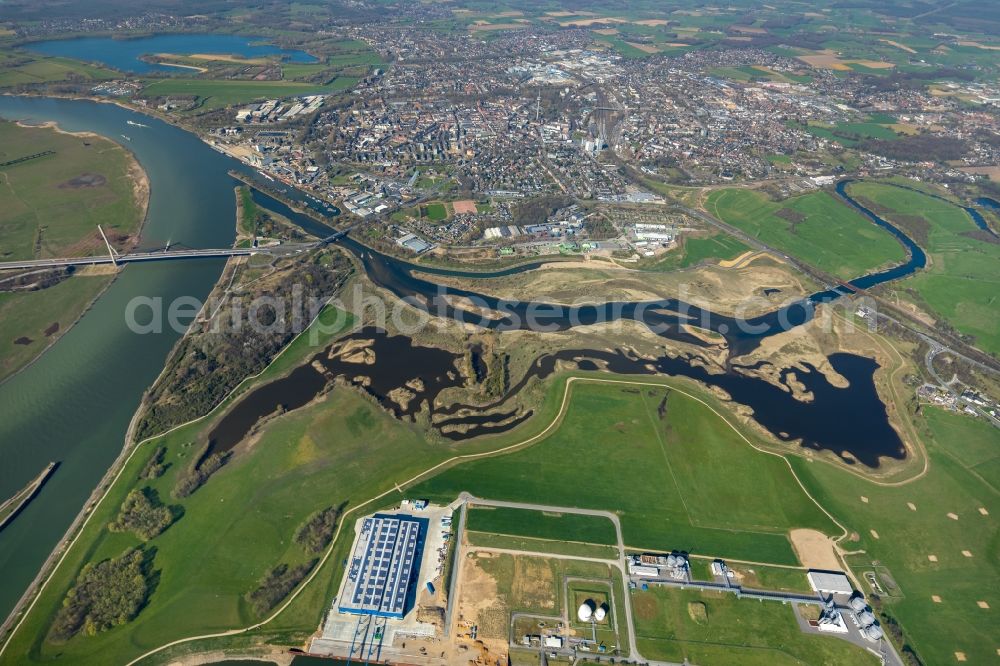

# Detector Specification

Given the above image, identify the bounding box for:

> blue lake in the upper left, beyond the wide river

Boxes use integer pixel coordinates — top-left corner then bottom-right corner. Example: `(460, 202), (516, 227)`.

(25, 34), (317, 74)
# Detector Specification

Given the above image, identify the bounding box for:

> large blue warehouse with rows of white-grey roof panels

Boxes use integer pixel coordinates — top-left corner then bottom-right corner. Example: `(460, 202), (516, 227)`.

(339, 514), (427, 618)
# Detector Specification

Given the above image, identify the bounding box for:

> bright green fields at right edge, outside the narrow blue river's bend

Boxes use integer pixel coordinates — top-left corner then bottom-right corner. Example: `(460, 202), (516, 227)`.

(850, 182), (1000, 354)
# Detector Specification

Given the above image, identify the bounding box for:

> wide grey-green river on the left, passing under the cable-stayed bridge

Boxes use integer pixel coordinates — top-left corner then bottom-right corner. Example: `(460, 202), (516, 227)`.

(0, 96), (236, 616)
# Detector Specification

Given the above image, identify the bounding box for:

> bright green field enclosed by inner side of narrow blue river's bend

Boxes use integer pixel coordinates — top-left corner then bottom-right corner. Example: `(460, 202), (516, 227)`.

(705, 189), (906, 279)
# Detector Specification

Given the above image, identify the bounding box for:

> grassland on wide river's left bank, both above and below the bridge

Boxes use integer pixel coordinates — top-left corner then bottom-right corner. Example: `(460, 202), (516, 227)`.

(0, 122), (143, 379)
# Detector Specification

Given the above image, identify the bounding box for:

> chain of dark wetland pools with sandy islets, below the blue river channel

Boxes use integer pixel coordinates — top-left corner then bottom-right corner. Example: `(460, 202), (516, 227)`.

(208, 327), (907, 469)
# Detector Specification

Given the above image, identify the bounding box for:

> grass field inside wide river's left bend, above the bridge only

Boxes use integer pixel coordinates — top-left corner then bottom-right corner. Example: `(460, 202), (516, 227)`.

(0, 122), (142, 261)
